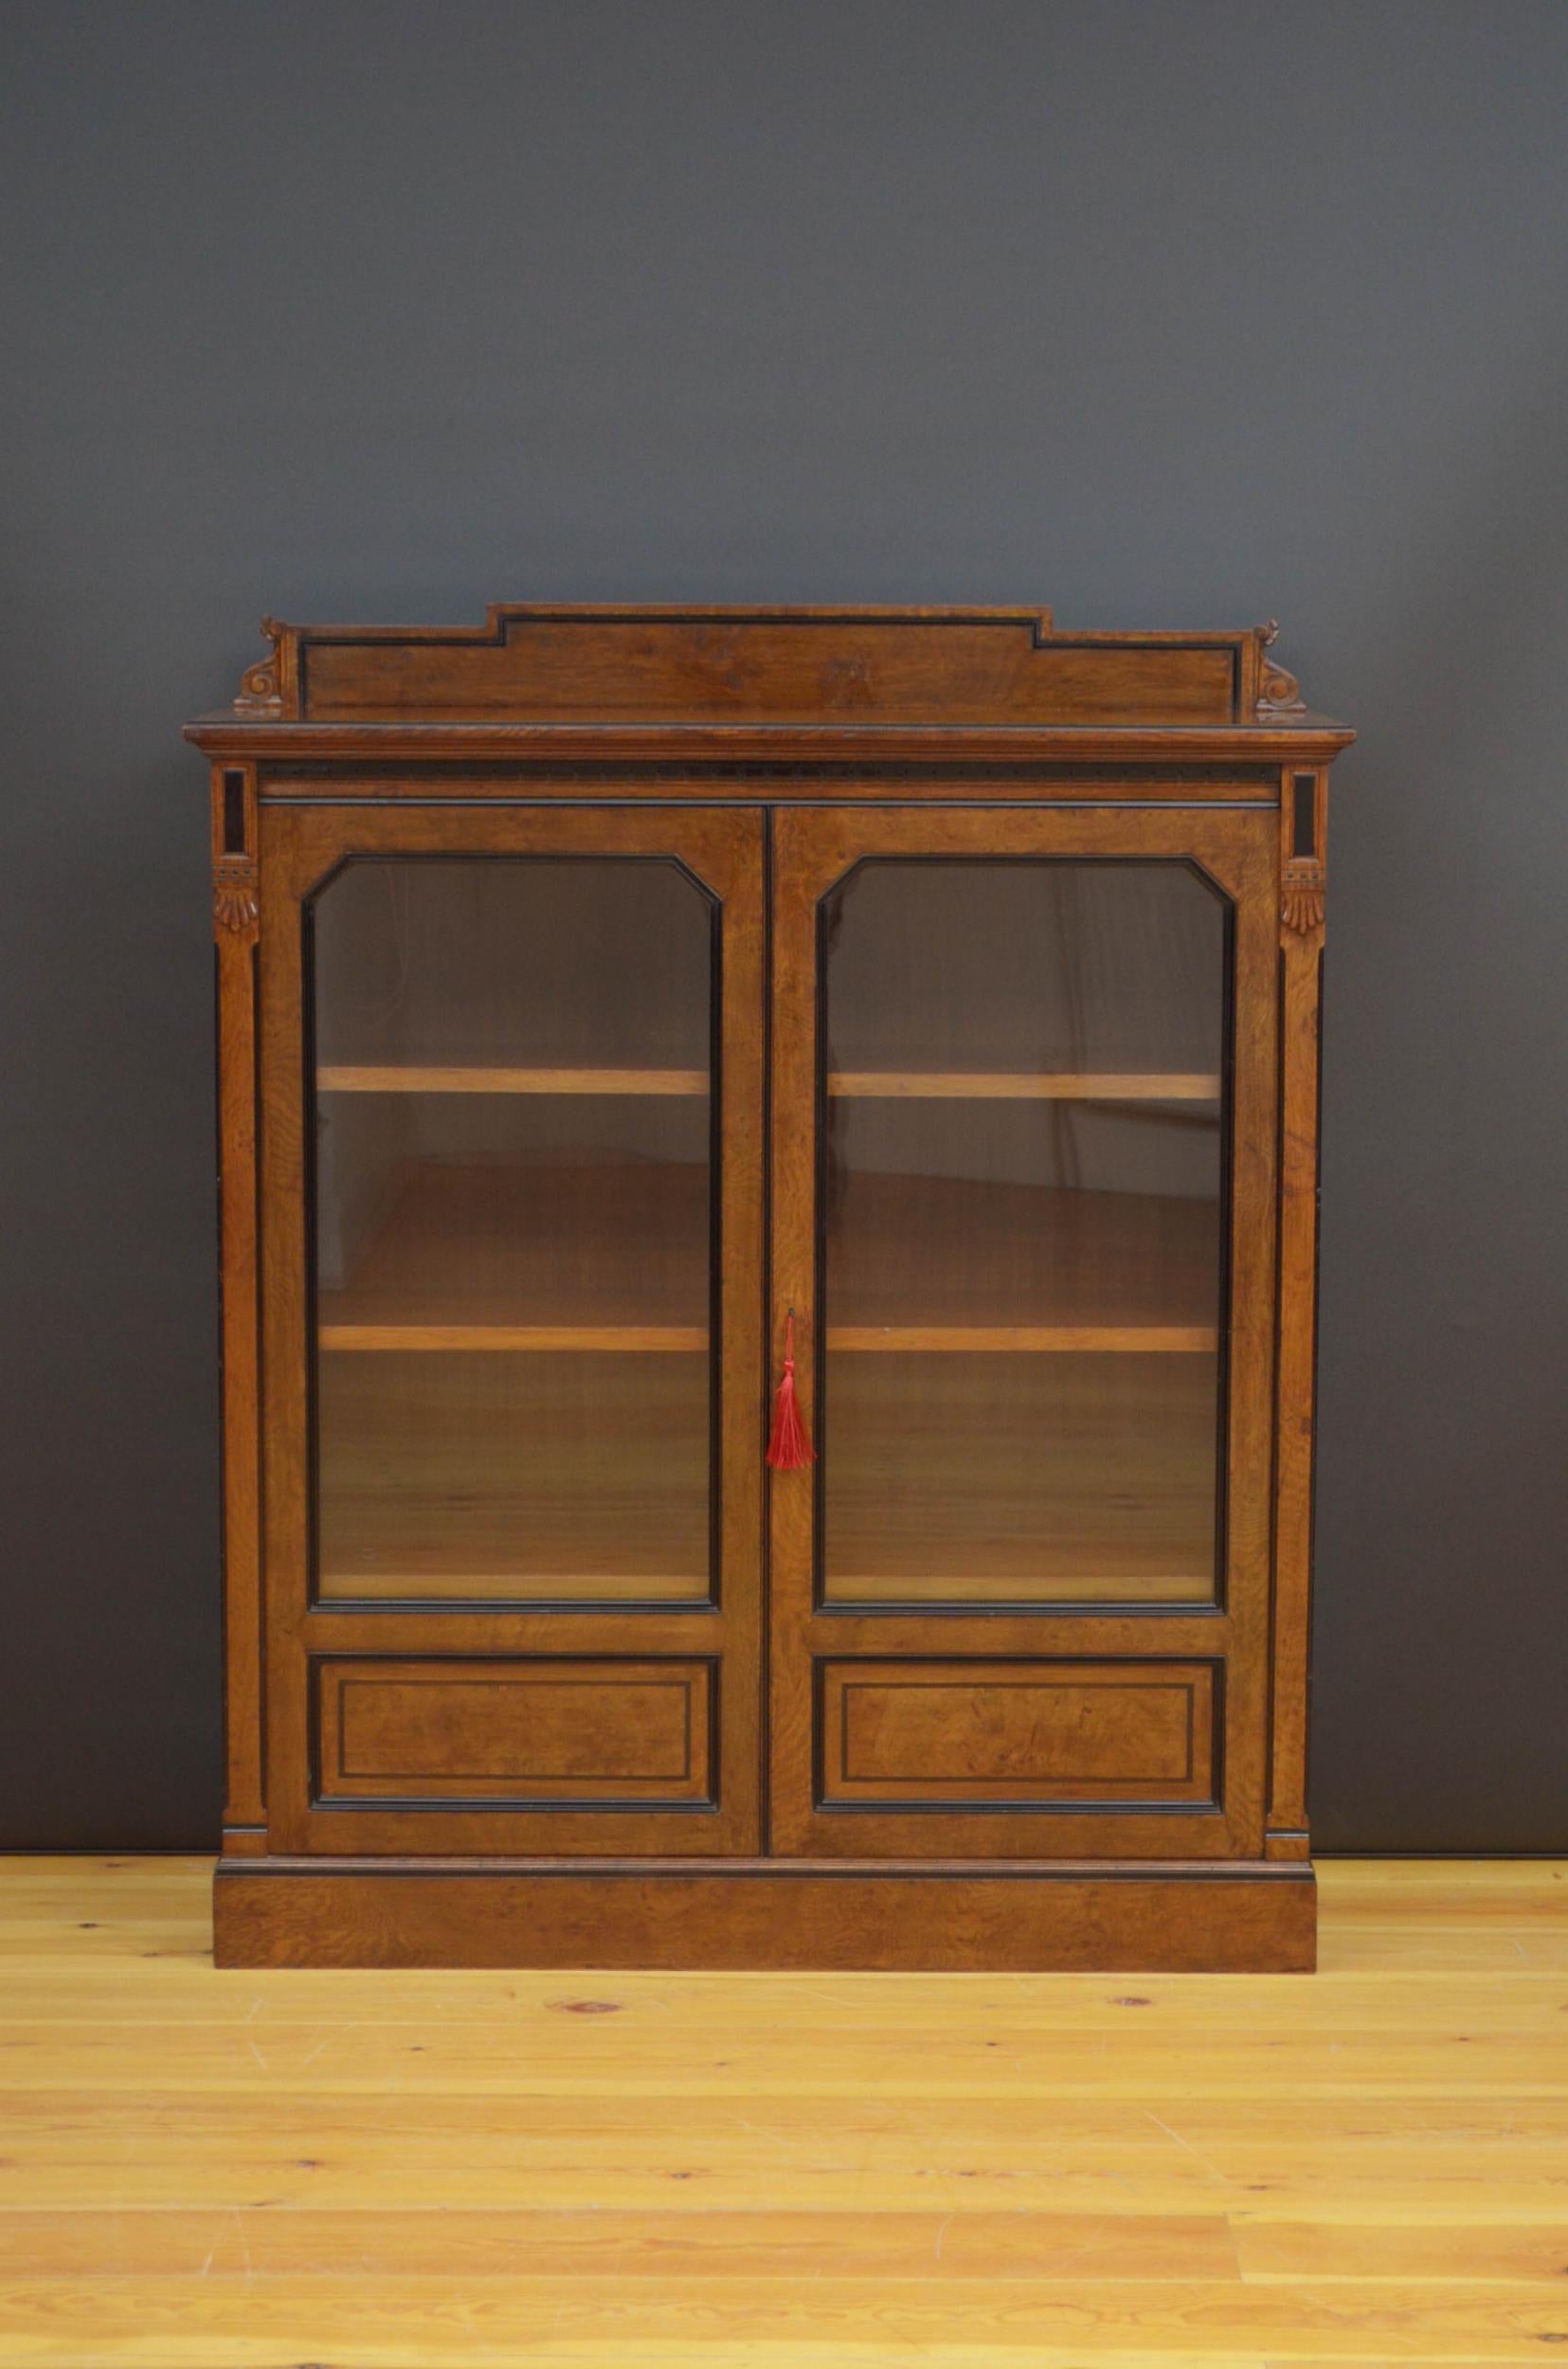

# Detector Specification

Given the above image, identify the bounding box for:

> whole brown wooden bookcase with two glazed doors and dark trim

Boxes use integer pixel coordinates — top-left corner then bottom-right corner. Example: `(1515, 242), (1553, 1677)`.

(188, 606), (1350, 1969)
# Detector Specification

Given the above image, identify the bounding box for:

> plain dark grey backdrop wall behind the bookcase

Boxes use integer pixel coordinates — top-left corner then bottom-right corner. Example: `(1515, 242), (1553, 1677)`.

(0, 0), (1568, 1851)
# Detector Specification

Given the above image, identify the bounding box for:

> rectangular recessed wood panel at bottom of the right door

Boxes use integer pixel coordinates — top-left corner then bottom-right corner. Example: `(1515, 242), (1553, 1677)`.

(820, 1661), (1216, 1810)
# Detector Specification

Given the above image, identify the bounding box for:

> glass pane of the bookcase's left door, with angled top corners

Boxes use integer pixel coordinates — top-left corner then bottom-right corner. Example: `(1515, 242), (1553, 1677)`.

(311, 858), (715, 1601)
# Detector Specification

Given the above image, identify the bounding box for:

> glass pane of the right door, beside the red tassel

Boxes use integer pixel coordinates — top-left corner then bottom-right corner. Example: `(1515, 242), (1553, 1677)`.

(820, 860), (1230, 1604)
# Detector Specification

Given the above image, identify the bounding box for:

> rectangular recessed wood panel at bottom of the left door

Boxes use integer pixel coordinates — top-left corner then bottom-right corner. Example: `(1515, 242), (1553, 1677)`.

(315, 1658), (713, 1808)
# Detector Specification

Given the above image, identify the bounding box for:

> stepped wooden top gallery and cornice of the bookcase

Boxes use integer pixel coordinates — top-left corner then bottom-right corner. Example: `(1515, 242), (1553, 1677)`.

(185, 605), (1353, 763)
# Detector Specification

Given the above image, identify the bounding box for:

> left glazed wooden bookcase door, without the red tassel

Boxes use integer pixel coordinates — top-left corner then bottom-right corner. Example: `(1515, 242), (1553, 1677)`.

(261, 801), (763, 1855)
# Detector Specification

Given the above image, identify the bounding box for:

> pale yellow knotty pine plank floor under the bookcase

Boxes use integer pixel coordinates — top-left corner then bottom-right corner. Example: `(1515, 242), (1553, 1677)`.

(0, 1860), (1568, 2369)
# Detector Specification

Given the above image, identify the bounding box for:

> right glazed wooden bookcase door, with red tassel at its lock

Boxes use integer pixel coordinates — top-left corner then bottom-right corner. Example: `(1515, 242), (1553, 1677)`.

(770, 805), (1277, 1860)
